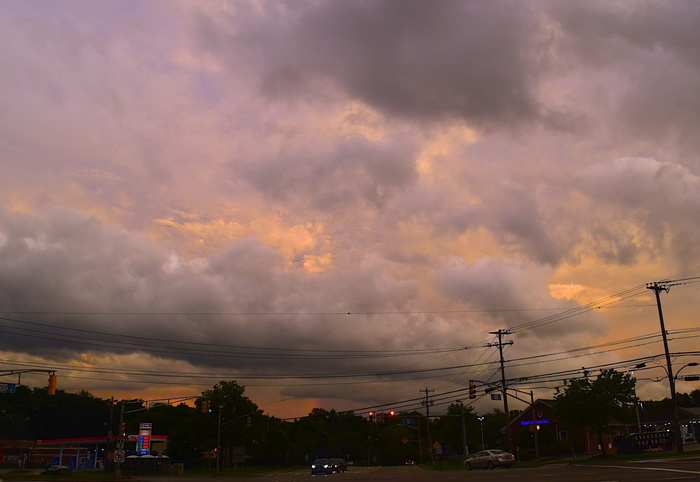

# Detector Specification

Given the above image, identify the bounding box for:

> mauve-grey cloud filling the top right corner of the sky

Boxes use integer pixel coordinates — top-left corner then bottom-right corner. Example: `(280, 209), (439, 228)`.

(547, 0), (700, 153)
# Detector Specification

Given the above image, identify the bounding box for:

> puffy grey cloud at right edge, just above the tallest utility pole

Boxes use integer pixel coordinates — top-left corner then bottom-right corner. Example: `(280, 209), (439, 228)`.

(581, 158), (700, 273)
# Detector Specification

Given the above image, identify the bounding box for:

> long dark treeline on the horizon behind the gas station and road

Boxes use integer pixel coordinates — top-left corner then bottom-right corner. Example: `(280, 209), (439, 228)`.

(0, 381), (505, 466)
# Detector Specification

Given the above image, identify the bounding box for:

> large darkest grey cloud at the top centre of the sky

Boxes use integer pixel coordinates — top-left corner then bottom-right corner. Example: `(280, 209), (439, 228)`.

(201, 0), (541, 127)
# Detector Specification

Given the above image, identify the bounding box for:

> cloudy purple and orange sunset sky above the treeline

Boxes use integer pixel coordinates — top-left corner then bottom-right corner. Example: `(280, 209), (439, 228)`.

(0, 0), (700, 418)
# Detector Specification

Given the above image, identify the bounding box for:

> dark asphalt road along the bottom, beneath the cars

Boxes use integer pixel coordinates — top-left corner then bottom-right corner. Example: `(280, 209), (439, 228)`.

(139, 456), (700, 482)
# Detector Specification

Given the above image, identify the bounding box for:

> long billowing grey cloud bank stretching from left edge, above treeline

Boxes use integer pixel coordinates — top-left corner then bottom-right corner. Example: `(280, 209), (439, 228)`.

(0, 207), (442, 373)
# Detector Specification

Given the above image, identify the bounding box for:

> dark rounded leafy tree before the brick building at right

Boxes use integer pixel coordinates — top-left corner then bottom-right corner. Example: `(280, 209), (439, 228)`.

(554, 370), (637, 455)
